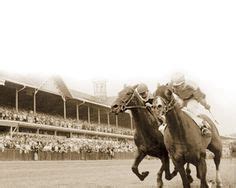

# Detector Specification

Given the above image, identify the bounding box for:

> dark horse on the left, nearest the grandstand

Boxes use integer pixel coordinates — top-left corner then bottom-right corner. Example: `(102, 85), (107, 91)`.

(111, 86), (176, 187)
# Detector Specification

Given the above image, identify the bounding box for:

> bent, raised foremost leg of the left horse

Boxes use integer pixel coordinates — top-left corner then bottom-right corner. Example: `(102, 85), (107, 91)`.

(132, 150), (149, 181)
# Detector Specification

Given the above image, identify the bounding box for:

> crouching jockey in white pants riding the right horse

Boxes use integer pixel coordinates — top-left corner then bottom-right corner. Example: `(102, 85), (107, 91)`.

(170, 73), (211, 137)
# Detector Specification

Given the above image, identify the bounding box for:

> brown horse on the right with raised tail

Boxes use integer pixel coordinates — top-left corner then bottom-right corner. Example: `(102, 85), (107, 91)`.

(155, 85), (222, 188)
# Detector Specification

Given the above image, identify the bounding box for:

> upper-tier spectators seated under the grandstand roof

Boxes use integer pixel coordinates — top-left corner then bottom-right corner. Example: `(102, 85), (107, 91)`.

(0, 106), (134, 135)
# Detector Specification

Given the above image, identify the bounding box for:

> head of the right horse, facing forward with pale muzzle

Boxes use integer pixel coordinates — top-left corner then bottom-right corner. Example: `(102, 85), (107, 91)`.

(154, 85), (175, 113)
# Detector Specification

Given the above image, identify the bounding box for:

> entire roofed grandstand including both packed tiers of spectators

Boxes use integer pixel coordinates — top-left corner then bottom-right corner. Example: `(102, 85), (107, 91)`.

(0, 72), (235, 160)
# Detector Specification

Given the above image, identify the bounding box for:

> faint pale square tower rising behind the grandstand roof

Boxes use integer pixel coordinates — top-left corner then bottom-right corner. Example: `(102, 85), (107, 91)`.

(93, 80), (107, 101)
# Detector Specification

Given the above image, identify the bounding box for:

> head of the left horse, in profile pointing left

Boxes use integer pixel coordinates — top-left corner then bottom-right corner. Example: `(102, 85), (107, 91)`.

(111, 85), (141, 114)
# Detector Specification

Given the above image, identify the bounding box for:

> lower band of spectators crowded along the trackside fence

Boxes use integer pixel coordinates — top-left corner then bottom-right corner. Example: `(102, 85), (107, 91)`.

(0, 134), (136, 155)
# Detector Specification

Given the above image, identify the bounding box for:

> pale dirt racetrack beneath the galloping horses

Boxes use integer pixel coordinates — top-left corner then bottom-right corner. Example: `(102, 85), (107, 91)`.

(0, 158), (236, 188)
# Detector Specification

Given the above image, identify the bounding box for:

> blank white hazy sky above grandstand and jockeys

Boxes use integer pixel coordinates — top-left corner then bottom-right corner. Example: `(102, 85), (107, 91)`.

(0, 0), (236, 133)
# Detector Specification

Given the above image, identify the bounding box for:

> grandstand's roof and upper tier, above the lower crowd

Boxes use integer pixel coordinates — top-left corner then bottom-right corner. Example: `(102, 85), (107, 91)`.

(0, 73), (133, 139)
